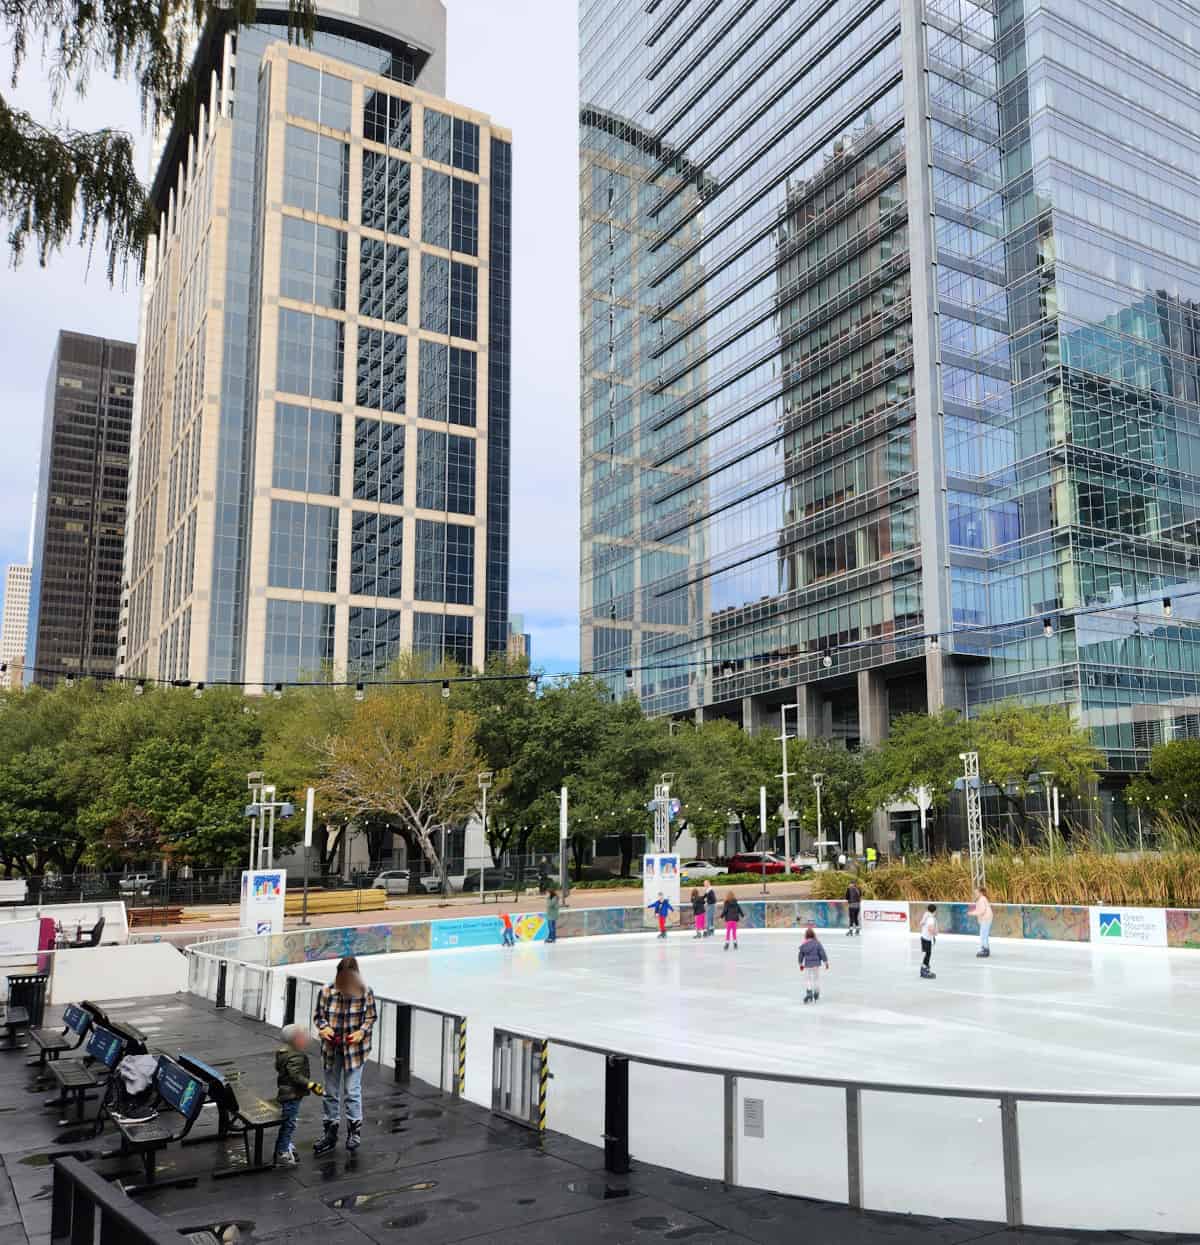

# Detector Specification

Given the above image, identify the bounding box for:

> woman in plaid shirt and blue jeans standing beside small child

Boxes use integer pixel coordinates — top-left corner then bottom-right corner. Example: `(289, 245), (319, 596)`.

(312, 955), (376, 1154)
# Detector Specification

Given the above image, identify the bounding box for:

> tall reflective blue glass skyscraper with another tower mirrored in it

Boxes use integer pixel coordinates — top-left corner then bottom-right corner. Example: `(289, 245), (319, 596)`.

(580, 0), (1200, 821)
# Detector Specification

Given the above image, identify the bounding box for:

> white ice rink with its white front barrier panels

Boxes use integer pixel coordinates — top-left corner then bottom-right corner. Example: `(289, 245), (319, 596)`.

(291, 930), (1200, 1231)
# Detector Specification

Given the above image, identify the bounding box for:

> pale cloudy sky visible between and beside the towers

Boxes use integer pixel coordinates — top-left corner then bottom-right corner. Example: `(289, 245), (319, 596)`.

(0, 0), (579, 671)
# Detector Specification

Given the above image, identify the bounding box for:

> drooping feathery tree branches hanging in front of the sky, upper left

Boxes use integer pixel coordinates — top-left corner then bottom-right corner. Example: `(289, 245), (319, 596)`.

(0, 0), (316, 281)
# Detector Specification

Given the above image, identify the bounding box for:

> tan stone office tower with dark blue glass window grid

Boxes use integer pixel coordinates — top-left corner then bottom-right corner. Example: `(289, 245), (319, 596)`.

(121, 0), (512, 687)
